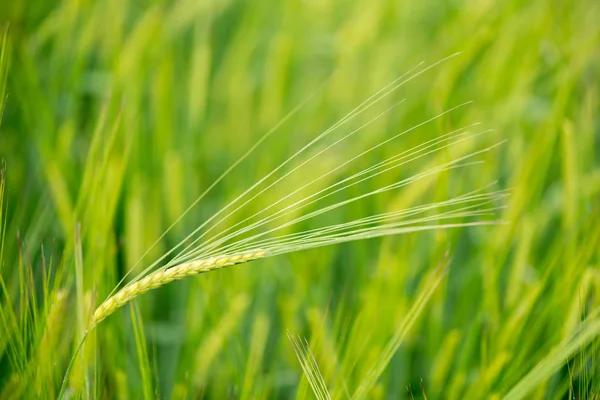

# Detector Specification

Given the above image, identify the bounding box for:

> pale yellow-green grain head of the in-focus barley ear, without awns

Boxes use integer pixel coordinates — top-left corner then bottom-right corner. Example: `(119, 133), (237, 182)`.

(91, 249), (268, 328)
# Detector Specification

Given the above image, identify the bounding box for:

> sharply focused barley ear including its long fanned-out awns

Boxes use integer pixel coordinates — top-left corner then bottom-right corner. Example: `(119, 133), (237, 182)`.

(90, 53), (508, 328)
